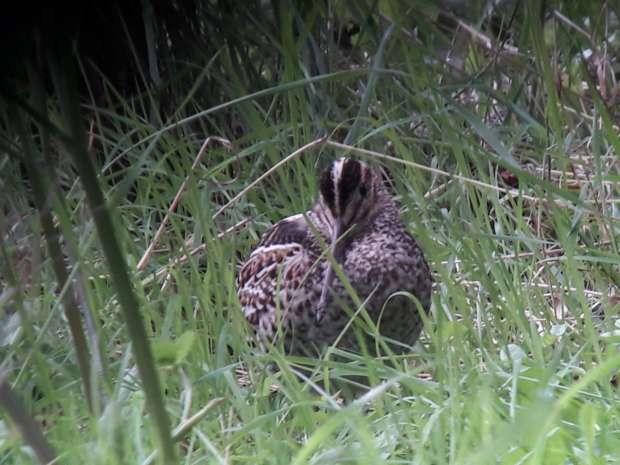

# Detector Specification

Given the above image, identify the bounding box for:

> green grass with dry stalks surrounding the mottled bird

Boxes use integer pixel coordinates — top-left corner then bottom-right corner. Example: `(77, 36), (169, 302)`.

(0, 2), (620, 465)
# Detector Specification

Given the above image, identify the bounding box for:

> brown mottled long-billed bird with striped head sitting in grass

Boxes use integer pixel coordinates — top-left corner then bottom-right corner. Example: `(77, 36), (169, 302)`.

(236, 157), (433, 355)
